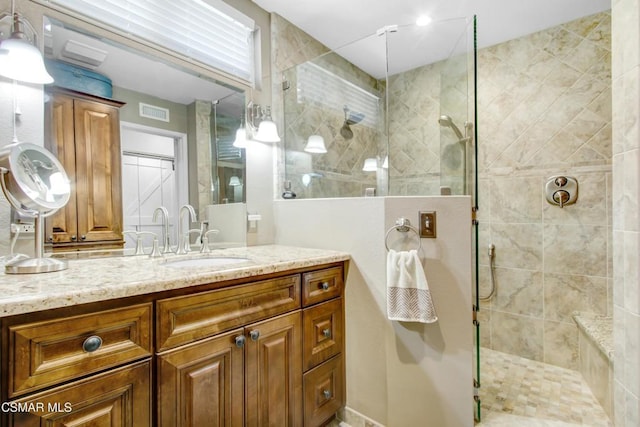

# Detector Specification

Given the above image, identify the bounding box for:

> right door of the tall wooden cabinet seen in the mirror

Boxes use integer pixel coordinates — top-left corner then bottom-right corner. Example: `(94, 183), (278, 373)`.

(74, 99), (122, 242)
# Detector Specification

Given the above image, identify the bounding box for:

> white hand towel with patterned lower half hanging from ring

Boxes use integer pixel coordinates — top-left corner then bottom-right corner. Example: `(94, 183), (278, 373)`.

(387, 249), (438, 323)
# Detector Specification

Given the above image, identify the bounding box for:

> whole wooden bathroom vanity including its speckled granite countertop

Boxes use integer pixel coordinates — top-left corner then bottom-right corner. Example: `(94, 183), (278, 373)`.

(0, 246), (349, 427)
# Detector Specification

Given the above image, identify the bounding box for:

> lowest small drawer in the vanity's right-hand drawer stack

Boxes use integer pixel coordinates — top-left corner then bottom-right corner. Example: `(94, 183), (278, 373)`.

(303, 355), (345, 427)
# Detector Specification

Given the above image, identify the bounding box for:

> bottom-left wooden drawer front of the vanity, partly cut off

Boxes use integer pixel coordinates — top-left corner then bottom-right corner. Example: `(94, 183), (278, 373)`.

(5, 360), (152, 427)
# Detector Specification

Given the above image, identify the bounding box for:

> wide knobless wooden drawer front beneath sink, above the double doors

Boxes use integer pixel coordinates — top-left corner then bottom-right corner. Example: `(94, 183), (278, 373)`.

(156, 274), (300, 351)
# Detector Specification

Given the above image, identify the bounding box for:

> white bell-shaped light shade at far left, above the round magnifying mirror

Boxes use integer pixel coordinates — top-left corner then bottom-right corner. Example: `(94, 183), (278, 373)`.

(0, 11), (53, 84)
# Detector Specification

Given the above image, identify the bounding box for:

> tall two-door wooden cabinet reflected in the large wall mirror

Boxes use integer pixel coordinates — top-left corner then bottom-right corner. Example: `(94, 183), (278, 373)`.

(45, 89), (124, 249)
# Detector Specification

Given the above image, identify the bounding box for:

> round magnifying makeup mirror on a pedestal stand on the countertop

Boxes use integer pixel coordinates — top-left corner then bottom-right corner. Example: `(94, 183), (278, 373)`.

(0, 142), (71, 274)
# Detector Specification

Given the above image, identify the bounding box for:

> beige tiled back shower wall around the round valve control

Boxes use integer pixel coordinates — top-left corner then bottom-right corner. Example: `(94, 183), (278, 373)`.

(478, 12), (612, 369)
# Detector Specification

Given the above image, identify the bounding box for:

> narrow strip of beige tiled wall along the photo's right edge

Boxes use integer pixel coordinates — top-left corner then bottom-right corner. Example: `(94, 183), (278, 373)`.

(612, 0), (640, 427)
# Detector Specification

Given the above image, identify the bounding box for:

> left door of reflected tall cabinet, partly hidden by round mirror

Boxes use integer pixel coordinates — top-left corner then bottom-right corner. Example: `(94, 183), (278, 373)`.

(45, 94), (78, 243)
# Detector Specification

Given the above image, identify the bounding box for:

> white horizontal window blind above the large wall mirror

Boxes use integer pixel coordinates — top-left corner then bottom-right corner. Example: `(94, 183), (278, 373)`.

(50, 0), (255, 84)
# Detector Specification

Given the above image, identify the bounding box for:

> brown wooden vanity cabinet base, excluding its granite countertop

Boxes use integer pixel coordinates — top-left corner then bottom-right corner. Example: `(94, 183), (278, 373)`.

(0, 263), (345, 427)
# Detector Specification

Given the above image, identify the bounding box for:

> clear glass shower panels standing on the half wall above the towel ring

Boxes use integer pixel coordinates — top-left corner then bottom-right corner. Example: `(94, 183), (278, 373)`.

(280, 17), (480, 419)
